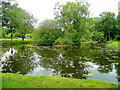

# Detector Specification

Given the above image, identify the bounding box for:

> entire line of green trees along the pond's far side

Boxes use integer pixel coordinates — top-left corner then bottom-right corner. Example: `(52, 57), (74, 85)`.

(1, 1), (120, 45)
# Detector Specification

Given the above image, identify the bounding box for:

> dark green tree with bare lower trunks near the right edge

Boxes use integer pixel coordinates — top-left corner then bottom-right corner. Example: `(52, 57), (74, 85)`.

(99, 12), (117, 40)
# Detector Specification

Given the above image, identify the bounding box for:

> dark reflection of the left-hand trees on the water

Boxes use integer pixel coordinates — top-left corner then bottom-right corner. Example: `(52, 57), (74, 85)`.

(2, 46), (37, 74)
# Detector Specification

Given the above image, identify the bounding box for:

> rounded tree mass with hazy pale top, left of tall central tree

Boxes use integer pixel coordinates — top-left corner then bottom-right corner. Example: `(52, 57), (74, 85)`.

(33, 19), (62, 45)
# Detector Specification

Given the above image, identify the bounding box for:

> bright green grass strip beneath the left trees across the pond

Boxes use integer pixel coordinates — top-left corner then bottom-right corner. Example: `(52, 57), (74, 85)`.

(0, 39), (33, 45)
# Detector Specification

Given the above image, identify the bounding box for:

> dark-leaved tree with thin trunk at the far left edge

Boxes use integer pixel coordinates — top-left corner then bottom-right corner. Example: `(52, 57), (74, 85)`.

(1, 0), (17, 42)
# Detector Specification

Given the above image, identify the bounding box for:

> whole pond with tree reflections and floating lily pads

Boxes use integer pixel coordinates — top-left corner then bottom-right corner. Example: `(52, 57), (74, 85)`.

(0, 43), (120, 83)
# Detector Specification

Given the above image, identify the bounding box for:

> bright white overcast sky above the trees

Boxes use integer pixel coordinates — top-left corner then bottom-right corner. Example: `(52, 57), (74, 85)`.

(17, 0), (120, 22)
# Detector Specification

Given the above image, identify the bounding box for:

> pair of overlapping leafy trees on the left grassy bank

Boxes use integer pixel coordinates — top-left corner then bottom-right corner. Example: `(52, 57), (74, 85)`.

(2, 0), (35, 40)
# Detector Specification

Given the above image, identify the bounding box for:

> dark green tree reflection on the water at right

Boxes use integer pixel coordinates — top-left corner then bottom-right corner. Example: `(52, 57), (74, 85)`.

(93, 48), (119, 73)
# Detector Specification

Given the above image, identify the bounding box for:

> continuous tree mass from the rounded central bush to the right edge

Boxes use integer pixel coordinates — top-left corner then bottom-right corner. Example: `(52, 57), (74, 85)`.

(34, 1), (120, 45)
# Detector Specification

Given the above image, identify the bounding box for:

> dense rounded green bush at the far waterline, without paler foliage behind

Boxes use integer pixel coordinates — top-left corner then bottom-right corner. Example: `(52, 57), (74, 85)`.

(33, 28), (62, 46)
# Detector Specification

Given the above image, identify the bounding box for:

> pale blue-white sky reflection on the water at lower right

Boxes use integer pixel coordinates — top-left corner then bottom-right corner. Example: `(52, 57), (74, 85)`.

(87, 62), (118, 83)
